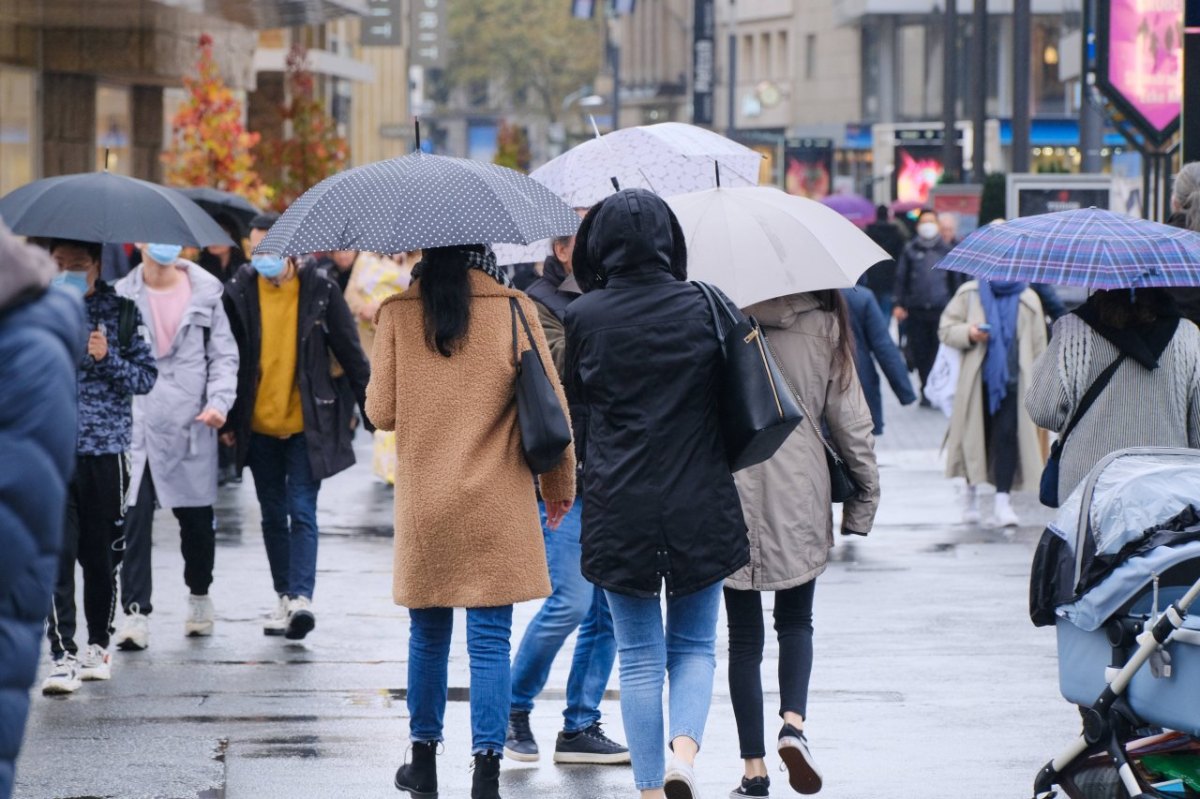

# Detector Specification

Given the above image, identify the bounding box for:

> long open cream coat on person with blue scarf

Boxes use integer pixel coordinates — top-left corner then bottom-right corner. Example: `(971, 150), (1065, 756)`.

(937, 281), (1046, 491)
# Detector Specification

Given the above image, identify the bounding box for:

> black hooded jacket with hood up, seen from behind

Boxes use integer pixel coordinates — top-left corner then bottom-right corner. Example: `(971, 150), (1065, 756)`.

(565, 190), (750, 596)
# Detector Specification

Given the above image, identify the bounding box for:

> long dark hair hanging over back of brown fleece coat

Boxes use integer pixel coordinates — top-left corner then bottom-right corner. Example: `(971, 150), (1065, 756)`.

(414, 246), (485, 358)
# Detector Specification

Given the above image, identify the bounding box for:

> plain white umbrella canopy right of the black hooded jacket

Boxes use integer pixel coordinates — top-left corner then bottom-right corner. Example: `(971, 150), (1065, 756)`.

(667, 186), (888, 308)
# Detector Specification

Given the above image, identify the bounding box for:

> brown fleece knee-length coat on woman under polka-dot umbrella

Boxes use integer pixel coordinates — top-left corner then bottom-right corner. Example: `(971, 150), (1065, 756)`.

(366, 270), (575, 608)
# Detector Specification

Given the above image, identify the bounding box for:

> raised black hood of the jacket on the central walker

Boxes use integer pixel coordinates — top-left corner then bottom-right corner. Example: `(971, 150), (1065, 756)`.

(586, 188), (678, 277)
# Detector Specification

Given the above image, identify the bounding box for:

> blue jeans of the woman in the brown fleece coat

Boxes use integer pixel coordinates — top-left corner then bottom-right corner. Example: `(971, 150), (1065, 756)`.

(408, 605), (512, 757)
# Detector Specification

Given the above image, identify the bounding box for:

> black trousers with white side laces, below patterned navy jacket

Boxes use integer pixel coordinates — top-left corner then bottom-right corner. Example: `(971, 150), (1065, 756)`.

(47, 455), (130, 659)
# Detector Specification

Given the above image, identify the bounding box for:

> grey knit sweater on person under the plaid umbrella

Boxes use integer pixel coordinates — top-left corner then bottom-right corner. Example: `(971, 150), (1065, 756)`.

(1025, 314), (1200, 500)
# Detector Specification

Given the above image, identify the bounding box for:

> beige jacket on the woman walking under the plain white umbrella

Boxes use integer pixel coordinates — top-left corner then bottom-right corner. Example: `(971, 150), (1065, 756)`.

(725, 294), (880, 591)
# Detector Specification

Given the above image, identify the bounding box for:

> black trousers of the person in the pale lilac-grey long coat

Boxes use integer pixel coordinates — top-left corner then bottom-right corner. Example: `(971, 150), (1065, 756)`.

(121, 463), (217, 615)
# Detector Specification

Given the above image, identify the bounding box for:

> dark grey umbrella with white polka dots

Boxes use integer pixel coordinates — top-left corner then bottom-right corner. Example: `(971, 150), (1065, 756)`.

(256, 152), (580, 256)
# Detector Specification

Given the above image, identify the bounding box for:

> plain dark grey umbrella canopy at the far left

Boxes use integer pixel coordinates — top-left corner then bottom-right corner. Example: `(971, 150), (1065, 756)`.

(0, 172), (233, 247)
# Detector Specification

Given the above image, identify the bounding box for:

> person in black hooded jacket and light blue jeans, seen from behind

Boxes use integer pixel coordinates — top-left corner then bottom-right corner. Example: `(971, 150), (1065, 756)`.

(564, 188), (750, 799)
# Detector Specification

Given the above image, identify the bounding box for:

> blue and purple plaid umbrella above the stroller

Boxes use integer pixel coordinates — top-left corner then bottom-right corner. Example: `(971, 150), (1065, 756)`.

(938, 208), (1200, 289)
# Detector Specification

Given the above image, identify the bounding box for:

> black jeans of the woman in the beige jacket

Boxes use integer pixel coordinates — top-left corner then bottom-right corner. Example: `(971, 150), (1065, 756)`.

(725, 581), (816, 759)
